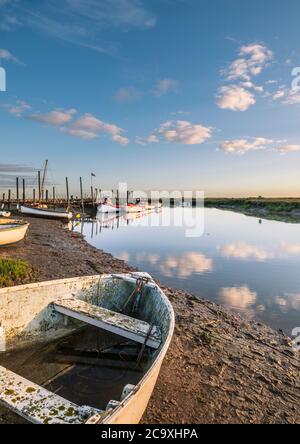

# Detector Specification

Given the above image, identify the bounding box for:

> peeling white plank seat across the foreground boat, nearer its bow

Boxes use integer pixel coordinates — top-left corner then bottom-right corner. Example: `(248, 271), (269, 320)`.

(54, 298), (162, 349)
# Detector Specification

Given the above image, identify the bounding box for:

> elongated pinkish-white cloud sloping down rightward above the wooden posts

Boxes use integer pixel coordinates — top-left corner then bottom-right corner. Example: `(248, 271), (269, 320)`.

(64, 114), (129, 146)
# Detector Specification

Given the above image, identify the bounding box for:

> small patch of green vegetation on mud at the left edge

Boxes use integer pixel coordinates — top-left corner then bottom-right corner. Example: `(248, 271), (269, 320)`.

(0, 258), (32, 287)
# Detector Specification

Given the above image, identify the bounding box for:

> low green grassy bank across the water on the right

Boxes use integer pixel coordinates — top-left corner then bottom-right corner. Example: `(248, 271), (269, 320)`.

(205, 199), (300, 223)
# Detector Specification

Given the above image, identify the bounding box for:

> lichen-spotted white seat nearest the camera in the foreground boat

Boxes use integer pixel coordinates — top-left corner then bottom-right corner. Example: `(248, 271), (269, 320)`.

(0, 366), (99, 424)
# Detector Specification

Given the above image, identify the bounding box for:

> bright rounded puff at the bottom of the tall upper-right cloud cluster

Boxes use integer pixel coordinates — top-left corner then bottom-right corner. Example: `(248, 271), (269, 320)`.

(217, 85), (256, 111)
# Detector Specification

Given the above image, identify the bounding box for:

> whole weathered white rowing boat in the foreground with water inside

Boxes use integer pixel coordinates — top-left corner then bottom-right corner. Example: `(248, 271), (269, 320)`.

(0, 273), (174, 424)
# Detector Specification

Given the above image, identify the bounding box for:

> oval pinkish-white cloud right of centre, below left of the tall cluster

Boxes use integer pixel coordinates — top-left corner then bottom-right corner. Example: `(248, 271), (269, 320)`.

(157, 120), (212, 145)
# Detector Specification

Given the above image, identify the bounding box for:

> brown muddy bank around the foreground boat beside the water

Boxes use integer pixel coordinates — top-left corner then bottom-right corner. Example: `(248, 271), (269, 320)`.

(0, 219), (300, 423)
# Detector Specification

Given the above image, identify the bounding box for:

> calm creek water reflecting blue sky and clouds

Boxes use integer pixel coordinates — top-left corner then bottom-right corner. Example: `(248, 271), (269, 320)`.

(76, 208), (300, 334)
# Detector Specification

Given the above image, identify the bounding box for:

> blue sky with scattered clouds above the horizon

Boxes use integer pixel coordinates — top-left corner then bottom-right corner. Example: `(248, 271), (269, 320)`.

(0, 0), (300, 196)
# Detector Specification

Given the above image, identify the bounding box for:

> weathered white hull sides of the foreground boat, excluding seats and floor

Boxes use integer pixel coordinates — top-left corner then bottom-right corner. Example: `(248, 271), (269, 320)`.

(0, 273), (174, 424)
